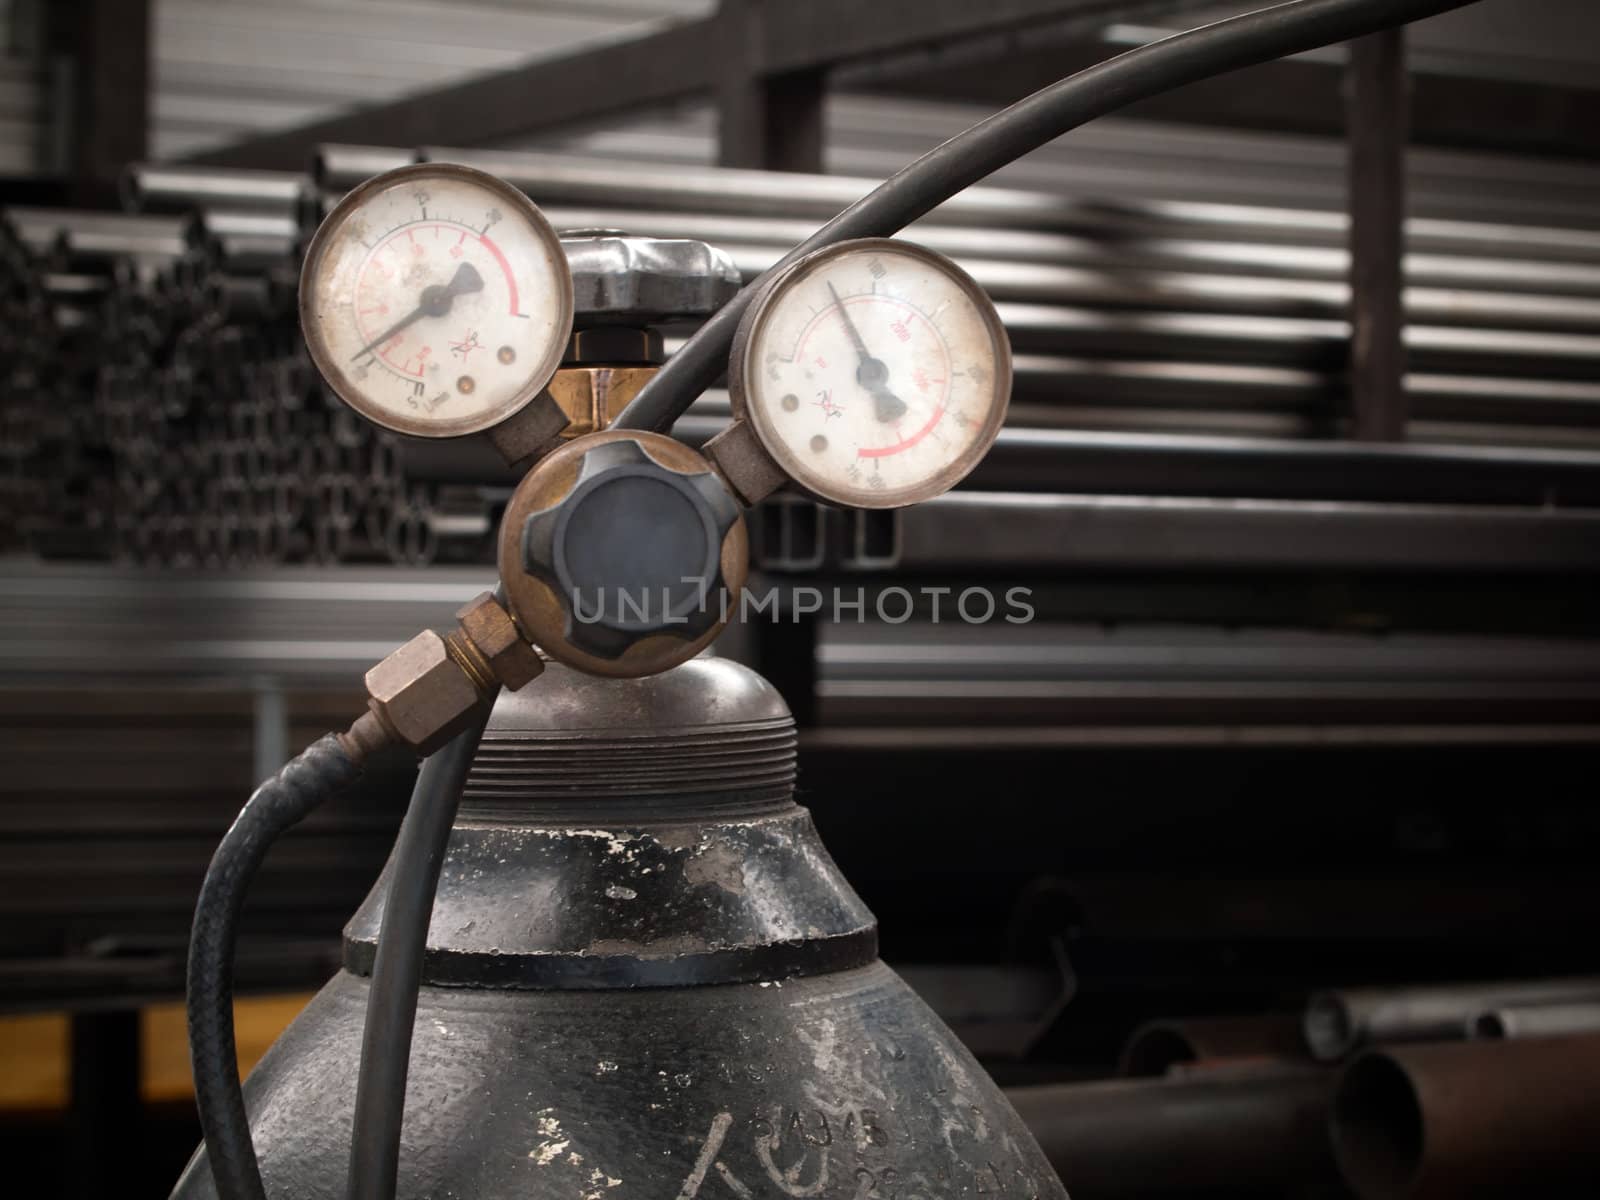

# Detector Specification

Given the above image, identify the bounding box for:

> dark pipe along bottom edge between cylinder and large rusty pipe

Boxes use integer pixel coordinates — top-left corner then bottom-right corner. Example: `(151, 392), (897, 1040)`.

(1006, 1067), (1334, 1197)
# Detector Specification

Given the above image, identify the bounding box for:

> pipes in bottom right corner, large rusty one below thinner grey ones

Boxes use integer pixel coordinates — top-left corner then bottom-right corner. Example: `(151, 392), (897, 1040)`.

(1304, 978), (1600, 1200)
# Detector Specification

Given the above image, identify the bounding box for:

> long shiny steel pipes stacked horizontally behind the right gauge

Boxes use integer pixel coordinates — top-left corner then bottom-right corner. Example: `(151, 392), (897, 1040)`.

(368, 146), (1600, 448)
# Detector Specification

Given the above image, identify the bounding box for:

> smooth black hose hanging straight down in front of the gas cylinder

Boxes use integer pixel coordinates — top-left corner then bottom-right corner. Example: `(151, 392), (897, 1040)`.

(349, 706), (490, 1200)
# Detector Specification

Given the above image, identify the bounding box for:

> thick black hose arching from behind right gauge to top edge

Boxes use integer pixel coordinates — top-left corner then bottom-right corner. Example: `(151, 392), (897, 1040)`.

(613, 0), (1475, 429)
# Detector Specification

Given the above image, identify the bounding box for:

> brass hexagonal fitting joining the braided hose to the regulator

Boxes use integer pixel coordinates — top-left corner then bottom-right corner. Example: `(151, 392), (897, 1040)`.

(353, 592), (544, 757)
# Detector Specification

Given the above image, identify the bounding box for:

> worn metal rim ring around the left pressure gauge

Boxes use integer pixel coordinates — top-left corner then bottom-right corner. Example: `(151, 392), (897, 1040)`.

(299, 162), (574, 438)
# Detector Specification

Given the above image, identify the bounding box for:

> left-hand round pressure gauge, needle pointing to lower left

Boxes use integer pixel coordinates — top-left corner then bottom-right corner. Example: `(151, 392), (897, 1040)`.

(301, 163), (573, 437)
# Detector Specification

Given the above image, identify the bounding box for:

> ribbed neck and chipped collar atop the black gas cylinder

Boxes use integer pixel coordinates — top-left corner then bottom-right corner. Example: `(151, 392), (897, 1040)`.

(344, 658), (877, 989)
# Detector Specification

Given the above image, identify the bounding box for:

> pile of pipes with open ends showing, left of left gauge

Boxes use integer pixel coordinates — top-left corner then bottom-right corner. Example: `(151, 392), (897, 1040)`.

(3, 166), (467, 566)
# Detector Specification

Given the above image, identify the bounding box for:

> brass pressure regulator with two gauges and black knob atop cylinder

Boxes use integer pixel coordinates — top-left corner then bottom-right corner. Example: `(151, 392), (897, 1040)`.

(301, 163), (1011, 723)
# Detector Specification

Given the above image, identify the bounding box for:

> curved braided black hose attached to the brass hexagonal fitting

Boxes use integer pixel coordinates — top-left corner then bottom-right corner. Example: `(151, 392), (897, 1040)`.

(189, 733), (362, 1200)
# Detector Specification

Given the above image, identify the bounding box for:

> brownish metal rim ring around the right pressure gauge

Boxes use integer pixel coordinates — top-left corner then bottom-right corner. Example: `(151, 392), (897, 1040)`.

(728, 237), (1013, 509)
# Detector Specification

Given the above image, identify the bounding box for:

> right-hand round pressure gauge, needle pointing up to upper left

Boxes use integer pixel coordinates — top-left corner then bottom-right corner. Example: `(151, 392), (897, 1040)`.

(733, 238), (1011, 509)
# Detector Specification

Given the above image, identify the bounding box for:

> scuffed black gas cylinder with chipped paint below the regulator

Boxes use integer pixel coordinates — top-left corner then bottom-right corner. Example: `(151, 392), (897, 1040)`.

(174, 658), (1066, 1200)
